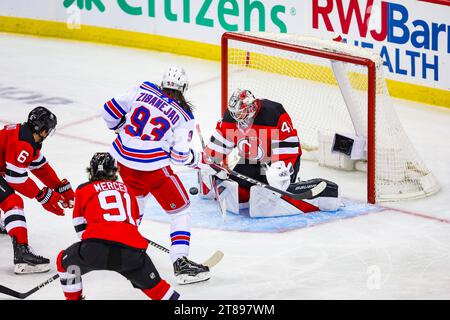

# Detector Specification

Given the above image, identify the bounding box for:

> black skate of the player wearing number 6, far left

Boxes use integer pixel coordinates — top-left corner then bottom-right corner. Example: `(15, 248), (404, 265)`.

(12, 237), (50, 274)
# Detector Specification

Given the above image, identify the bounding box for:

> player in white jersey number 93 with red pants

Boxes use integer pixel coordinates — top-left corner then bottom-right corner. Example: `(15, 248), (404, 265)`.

(103, 66), (210, 284)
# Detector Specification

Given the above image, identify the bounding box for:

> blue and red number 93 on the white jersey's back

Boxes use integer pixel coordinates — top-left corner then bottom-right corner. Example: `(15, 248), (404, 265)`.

(125, 106), (170, 141)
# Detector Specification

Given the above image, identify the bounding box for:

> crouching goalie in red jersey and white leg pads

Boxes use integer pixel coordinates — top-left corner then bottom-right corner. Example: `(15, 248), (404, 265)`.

(201, 89), (340, 217)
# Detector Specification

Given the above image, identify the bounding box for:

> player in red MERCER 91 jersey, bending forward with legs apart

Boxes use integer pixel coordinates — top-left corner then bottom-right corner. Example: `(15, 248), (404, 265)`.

(56, 152), (180, 300)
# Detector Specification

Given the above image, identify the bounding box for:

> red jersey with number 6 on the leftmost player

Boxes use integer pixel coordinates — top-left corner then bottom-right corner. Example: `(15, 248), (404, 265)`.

(0, 123), (60, 198)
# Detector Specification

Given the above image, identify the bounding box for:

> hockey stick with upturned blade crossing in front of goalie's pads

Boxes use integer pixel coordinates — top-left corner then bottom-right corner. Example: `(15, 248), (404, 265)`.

(208, 163), (327, 200)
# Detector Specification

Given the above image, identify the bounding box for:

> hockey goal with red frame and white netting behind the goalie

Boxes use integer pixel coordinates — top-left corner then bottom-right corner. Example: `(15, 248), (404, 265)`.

(222, 32), (439, 203)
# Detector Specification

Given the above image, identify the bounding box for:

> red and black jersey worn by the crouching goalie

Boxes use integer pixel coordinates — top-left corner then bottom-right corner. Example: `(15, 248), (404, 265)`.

(205, 100), (301, 164)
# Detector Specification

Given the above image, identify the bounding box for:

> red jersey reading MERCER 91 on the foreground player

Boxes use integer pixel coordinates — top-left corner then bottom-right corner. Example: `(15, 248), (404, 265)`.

(73, 181), (148, 249)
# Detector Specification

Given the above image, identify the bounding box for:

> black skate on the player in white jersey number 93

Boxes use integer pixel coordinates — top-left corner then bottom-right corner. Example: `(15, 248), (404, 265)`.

(173, 257), (211, 284)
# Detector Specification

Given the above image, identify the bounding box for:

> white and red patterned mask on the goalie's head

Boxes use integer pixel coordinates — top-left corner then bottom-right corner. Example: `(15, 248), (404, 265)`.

(228, 89), (258, 128)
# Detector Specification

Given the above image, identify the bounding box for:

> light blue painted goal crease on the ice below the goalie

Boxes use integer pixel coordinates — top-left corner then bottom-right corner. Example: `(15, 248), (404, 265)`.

(144, 171), (384, 233)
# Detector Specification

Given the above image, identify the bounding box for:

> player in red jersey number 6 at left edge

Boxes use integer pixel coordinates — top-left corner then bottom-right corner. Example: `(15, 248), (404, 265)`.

(0, 107), (73, 274)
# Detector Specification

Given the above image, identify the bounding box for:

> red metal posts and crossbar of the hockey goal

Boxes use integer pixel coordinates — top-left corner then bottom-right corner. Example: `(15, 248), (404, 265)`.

(221, 32), (376, 203)
